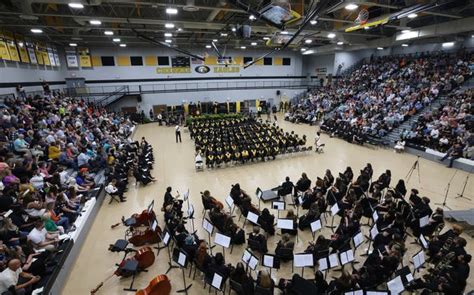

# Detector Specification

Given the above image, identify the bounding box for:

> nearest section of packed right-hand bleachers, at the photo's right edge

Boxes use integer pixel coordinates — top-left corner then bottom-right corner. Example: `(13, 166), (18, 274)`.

(400, 89), (474, 159)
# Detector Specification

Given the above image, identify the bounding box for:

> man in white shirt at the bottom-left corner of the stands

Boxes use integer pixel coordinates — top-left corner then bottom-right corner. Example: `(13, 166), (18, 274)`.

(0, 259), (41, 295)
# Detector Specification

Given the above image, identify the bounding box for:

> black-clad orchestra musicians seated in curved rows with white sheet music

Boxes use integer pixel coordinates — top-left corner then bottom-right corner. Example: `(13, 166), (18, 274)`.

(157, 164), (472, 294)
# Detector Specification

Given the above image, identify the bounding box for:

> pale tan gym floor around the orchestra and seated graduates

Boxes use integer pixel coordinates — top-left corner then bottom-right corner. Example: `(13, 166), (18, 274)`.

(62, 116), (474, 295)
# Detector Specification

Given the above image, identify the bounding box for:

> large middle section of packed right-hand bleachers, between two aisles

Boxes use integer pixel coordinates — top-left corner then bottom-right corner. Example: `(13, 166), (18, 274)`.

(321, 51), (472, 143)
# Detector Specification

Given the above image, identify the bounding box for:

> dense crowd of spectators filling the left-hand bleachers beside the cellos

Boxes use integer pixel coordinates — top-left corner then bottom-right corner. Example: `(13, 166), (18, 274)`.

(0, 92), (153, 294)
